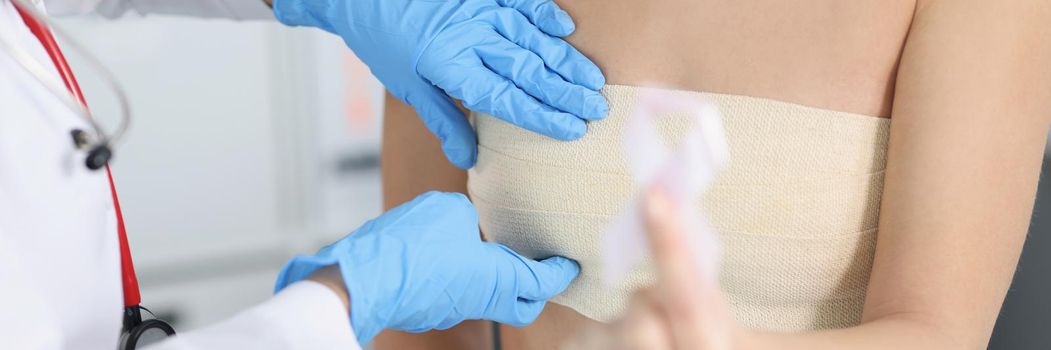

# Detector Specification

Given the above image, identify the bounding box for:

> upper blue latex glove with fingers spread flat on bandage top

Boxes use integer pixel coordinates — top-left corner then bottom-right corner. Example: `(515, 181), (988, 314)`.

(273, 0), (609, 168)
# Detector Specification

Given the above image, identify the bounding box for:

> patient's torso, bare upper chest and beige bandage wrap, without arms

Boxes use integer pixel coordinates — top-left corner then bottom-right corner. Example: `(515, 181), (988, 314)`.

(469, 0), (915, 350)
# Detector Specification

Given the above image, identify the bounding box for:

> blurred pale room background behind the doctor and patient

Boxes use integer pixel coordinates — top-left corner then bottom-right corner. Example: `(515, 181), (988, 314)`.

(60, 12), (1051, 349)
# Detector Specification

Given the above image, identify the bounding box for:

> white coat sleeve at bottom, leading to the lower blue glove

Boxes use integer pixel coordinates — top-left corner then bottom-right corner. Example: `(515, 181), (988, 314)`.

(148, 281), (362, 350)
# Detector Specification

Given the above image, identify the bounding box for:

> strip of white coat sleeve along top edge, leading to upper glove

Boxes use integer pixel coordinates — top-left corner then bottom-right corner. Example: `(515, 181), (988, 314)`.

(44, 0), (274, 20)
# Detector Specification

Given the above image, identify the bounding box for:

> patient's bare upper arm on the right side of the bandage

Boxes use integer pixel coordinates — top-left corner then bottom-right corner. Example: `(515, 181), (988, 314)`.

(864, 0), (1051, 348)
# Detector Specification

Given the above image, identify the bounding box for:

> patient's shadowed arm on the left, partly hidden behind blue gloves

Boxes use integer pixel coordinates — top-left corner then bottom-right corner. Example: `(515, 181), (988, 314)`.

(375, 94), (493, 350)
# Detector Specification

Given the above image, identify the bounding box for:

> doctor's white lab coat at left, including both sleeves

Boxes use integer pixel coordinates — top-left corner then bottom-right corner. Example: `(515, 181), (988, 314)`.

(0, 0), (359, 350)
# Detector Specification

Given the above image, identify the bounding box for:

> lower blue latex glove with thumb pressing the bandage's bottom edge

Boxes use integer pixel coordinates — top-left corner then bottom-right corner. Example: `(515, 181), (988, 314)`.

(275, 189), (580, 344)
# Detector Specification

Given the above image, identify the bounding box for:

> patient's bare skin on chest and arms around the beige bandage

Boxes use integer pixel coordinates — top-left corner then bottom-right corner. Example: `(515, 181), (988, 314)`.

(377, 0), (1051, 350)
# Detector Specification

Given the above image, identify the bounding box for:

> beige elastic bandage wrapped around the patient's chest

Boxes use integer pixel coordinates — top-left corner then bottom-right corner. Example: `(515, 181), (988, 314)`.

(468, 85), (890, 331)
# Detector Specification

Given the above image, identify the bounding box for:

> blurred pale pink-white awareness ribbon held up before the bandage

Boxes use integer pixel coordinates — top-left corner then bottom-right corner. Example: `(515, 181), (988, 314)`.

(602, 89), (727, 288)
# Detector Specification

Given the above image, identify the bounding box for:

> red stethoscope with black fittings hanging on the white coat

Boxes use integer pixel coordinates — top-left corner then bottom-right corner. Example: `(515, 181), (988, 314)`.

(12, 0), (176, 350)
